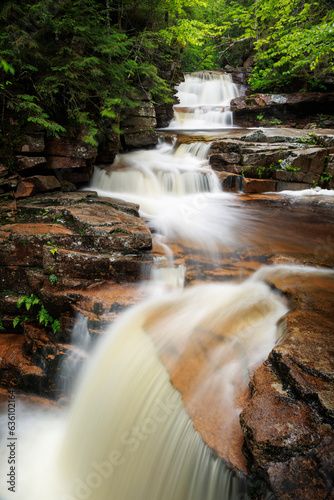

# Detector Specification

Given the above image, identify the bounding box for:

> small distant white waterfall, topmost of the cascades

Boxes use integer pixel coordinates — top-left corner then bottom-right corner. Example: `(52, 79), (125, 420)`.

(169, 72), (239, 130)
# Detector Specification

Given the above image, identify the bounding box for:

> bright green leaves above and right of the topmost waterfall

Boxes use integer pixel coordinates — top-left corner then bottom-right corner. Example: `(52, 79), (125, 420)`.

(183, 0), (334, 92)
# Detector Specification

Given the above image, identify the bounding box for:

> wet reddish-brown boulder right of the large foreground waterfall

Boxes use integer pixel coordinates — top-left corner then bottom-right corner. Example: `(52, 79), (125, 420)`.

(240, 277), (334, 500)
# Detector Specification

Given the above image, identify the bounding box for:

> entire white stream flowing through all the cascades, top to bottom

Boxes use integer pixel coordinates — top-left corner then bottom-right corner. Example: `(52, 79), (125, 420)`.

(0, 75), (330, 500)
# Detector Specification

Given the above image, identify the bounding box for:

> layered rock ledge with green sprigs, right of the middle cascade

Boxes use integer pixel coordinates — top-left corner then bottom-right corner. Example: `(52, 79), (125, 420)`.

(209, 128), (334, 194)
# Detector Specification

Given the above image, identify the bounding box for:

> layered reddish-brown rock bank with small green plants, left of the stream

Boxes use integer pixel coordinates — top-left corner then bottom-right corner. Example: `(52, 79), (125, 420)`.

(0, 191), (152, 397)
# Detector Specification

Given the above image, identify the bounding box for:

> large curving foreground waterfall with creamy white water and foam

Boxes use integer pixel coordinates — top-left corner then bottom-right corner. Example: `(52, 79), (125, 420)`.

(0, 281), (287, 500)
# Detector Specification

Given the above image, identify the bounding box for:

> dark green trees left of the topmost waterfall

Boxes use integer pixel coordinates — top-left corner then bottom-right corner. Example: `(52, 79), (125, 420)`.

(0, 0), (209, 146)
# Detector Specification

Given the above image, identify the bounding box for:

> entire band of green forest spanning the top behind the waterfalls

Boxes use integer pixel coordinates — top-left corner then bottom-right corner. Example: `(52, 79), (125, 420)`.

(0, 0), (334, 145)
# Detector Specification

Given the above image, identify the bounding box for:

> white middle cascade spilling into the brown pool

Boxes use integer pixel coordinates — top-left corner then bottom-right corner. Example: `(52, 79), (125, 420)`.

(89, 143), (251, 249)
